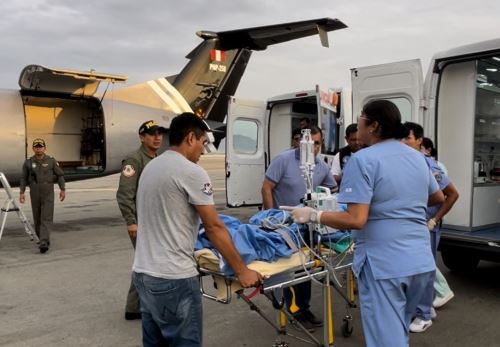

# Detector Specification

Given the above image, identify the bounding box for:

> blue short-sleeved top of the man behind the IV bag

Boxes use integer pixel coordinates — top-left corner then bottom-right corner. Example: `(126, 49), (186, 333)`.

(266, 149), (337, 208)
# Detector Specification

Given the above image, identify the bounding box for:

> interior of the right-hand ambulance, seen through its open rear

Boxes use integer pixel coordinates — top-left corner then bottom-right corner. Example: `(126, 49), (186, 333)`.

(435, 54), (500, 230)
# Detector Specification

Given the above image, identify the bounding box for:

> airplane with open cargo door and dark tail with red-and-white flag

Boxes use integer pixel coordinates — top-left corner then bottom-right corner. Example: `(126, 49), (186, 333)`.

(0, 18), (347, 186)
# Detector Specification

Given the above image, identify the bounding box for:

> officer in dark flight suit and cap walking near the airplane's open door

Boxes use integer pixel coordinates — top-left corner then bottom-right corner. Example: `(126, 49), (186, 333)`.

(19, 139), (66, 253)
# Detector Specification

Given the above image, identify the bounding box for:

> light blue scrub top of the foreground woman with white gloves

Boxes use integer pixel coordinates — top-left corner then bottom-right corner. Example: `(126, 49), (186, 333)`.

(338, 140), (439, 279)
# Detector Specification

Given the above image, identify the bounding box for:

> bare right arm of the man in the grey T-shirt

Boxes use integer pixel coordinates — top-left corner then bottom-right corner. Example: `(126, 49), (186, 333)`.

(194, 205), (262, 288)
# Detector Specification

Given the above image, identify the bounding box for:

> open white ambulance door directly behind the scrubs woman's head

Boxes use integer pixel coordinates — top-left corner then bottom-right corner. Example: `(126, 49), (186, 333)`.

(351, 59), (424, 123)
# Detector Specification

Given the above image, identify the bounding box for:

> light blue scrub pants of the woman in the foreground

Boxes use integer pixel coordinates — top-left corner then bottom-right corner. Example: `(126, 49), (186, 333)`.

(358, 259), (435, 347)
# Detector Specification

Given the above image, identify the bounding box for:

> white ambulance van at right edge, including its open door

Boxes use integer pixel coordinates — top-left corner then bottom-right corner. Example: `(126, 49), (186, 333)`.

(351, 39), (500, 271)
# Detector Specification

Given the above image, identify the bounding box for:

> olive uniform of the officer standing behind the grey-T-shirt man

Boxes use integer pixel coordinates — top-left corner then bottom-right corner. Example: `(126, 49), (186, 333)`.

(116, 145), (153, 313)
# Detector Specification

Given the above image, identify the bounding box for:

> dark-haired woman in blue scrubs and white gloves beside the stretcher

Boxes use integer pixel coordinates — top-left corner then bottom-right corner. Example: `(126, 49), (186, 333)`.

(292, 100), (444, 347)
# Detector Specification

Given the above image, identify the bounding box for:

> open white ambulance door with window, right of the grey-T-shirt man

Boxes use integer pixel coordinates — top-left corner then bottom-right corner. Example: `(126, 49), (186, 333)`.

(226, 98), (266, 207)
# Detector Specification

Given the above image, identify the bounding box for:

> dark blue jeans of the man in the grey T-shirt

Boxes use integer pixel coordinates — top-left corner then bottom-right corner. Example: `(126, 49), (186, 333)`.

(132, 272), (203, 347)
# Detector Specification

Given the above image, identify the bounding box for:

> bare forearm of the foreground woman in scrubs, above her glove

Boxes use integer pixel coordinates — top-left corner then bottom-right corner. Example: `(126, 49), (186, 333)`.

(319, 204), (370, 230)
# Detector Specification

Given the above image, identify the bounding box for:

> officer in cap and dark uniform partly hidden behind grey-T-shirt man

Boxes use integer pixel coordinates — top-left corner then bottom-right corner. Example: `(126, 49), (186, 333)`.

(116, 120), (166, 320)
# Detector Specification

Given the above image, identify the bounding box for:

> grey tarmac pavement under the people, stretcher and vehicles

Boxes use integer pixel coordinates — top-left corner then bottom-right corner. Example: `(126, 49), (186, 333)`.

(0, 155), (500, 347)
